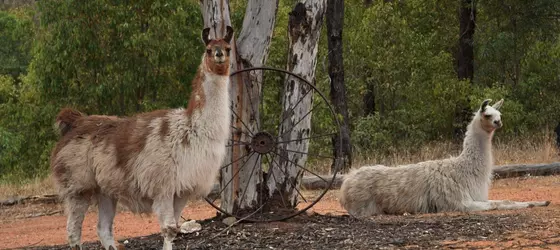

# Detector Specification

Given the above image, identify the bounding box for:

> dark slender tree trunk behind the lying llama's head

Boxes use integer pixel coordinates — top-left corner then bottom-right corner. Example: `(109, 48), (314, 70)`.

(454, 0), (476, 141)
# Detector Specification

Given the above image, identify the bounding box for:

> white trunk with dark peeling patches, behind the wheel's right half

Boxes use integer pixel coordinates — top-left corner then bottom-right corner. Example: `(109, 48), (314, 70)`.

(267, 0), (326, 208)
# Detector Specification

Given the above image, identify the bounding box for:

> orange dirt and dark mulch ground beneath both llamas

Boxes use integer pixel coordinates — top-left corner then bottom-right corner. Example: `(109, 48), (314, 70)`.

(0, 176), (560, 249)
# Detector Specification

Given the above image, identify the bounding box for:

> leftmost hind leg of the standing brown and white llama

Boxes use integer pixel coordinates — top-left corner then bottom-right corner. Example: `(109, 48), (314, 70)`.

(66, 196), (89, 249)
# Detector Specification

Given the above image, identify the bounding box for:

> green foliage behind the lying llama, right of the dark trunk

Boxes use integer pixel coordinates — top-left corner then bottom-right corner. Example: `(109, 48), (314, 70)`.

(344, 0), (560, 153)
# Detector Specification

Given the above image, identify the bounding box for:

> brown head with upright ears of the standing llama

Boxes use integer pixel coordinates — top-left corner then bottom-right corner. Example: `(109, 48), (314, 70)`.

(202, 26), (233, 75)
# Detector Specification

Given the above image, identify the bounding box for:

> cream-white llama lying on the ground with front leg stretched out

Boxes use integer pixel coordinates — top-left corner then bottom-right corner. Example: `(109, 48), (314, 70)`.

(340, 99), (550, 217)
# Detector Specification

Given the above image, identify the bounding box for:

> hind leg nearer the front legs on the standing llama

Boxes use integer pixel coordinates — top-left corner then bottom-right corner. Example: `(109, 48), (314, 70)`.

(97, 194), (121, 250)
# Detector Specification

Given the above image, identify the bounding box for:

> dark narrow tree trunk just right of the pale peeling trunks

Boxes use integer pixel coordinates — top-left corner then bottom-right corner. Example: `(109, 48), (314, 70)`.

(327, 0), (352, 173)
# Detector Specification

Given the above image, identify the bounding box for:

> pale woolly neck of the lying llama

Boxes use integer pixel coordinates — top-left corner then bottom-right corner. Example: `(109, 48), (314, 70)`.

(459, 115), (494, 173)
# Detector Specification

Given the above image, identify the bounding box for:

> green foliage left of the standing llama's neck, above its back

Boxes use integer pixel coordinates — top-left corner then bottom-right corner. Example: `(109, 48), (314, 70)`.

(0, 0), (209, 181)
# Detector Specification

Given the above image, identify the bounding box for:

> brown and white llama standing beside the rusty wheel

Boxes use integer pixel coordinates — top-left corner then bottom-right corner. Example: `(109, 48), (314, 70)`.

(51, 26), (233, 250)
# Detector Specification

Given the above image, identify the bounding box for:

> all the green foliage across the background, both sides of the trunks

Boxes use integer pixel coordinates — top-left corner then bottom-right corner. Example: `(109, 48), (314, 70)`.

(0, 0), (560, 181)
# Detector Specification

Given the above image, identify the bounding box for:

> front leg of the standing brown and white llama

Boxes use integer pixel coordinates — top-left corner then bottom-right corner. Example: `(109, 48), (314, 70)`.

(153, 198), (177, 250)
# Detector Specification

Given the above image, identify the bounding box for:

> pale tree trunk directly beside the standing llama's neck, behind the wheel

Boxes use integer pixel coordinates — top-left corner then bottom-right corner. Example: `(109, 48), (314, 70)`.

(201, 0), (278, 213)
